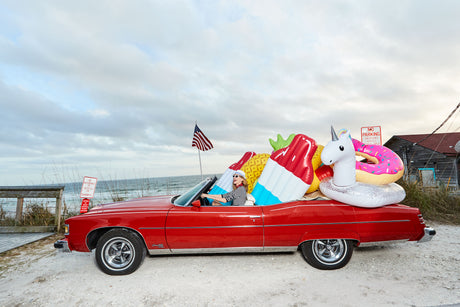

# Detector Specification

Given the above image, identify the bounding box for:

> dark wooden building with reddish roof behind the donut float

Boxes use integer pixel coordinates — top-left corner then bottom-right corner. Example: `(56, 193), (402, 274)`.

(384, 132), (460, 190)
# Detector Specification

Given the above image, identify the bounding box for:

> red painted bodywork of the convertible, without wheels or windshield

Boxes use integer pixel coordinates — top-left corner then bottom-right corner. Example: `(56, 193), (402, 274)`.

(66, 196), (425, 254)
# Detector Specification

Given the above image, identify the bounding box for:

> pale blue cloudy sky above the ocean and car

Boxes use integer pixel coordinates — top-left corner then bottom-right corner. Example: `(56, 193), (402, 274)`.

(0, 0), (460, 185)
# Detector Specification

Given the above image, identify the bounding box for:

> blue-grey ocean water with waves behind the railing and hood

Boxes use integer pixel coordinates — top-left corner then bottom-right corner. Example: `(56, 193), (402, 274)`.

(0, 175), (220, 217)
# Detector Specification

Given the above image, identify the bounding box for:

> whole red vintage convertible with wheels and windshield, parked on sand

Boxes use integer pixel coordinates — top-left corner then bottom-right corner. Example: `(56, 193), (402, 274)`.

(55, 177), (436, 275)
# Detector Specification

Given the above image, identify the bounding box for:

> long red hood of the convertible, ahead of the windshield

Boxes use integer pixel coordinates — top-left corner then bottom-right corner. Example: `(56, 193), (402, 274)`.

(90, 196), (172, 213)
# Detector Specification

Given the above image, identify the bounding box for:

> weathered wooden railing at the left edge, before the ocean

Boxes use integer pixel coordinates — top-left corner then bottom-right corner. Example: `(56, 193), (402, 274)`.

(0, 185), (65, 231)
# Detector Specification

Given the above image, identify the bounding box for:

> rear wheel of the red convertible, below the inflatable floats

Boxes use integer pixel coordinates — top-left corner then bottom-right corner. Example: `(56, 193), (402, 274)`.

(300, 239), (353, 270)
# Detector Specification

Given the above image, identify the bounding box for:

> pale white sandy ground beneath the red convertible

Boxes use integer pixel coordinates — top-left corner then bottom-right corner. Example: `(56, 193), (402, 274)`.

(0, 223), (460, 306)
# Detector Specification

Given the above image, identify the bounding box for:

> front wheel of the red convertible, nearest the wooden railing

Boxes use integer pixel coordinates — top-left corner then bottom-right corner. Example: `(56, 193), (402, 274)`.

(96, 228), (146, 275)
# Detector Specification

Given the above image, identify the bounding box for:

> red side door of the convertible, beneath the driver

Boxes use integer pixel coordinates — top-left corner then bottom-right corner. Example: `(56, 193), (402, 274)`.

(165, 206), (263, 253)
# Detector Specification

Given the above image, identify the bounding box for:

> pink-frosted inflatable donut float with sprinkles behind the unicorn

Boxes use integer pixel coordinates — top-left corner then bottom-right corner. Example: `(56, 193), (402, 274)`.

(352, 139), (404, 184)
